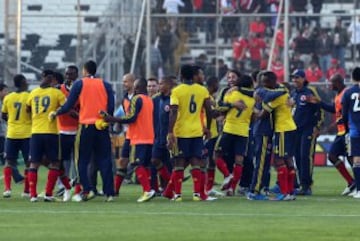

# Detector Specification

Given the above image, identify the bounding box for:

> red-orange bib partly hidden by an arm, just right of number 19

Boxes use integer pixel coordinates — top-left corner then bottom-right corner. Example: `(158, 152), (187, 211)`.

(57, 84), (79, 134)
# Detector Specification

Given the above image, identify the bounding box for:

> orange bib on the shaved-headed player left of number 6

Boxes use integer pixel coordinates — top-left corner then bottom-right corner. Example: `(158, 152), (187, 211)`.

(129, 94), (154, 145)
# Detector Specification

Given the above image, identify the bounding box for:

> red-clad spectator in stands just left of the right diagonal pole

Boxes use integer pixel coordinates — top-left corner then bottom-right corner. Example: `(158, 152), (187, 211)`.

(248, 33), (266, 69)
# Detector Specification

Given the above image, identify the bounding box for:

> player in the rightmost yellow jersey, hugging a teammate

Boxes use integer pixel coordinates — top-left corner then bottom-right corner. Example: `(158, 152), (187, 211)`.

(257, 71), (296, 200)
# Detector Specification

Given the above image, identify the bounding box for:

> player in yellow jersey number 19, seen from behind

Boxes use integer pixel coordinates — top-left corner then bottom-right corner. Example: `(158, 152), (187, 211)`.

(26, 70), (65, 202)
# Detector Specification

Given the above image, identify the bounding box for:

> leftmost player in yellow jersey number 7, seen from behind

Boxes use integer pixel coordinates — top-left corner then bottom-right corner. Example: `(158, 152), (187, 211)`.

(1, 74), (31, 198)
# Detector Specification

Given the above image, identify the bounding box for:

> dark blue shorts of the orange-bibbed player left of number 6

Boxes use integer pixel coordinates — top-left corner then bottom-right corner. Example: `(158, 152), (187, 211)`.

(130, 144), (152, 167)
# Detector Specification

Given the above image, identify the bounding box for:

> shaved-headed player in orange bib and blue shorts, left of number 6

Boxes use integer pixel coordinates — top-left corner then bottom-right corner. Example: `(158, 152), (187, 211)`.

(105, 78), (155, 203)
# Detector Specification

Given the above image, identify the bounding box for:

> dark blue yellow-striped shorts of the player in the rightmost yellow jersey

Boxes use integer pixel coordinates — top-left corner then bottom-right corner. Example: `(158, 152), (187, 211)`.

(274, 131), (296, 159)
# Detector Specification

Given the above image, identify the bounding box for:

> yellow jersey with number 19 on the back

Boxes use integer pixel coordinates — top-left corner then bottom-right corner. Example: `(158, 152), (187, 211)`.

(27, 87), (65, 134)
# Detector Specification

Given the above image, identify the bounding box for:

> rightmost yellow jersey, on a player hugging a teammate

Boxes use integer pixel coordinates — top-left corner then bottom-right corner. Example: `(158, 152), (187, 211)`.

(263, 93), (296, 132)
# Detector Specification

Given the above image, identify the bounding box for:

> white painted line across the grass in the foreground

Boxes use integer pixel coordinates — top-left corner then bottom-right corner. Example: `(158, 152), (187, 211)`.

(0, 209), (360, 218)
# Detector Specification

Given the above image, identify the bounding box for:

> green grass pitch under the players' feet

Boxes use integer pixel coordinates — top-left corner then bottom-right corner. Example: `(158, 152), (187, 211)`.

(0, 168), (360, 241)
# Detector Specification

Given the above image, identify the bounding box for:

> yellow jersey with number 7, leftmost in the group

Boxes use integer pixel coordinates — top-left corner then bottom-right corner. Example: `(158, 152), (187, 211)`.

(1, 91), (31, 139)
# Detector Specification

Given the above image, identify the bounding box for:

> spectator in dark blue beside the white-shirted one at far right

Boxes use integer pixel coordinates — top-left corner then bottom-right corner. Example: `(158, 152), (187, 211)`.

(332, 19), (349, 68)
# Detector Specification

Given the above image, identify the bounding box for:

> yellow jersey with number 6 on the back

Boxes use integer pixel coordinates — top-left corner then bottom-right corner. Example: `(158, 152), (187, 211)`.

(170, 84), (210, 138)
